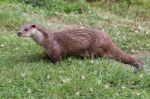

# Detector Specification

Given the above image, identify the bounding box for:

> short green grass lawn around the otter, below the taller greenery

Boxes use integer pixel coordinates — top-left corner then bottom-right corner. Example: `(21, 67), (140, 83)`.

(0, 0), (150, 99)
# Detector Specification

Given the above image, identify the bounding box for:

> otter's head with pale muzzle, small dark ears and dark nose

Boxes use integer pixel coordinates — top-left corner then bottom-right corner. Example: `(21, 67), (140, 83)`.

(17, 24), (39, 37)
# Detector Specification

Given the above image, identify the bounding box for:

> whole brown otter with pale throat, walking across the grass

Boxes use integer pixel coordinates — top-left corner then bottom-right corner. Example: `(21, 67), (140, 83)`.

(17, 23), (144, 70)
